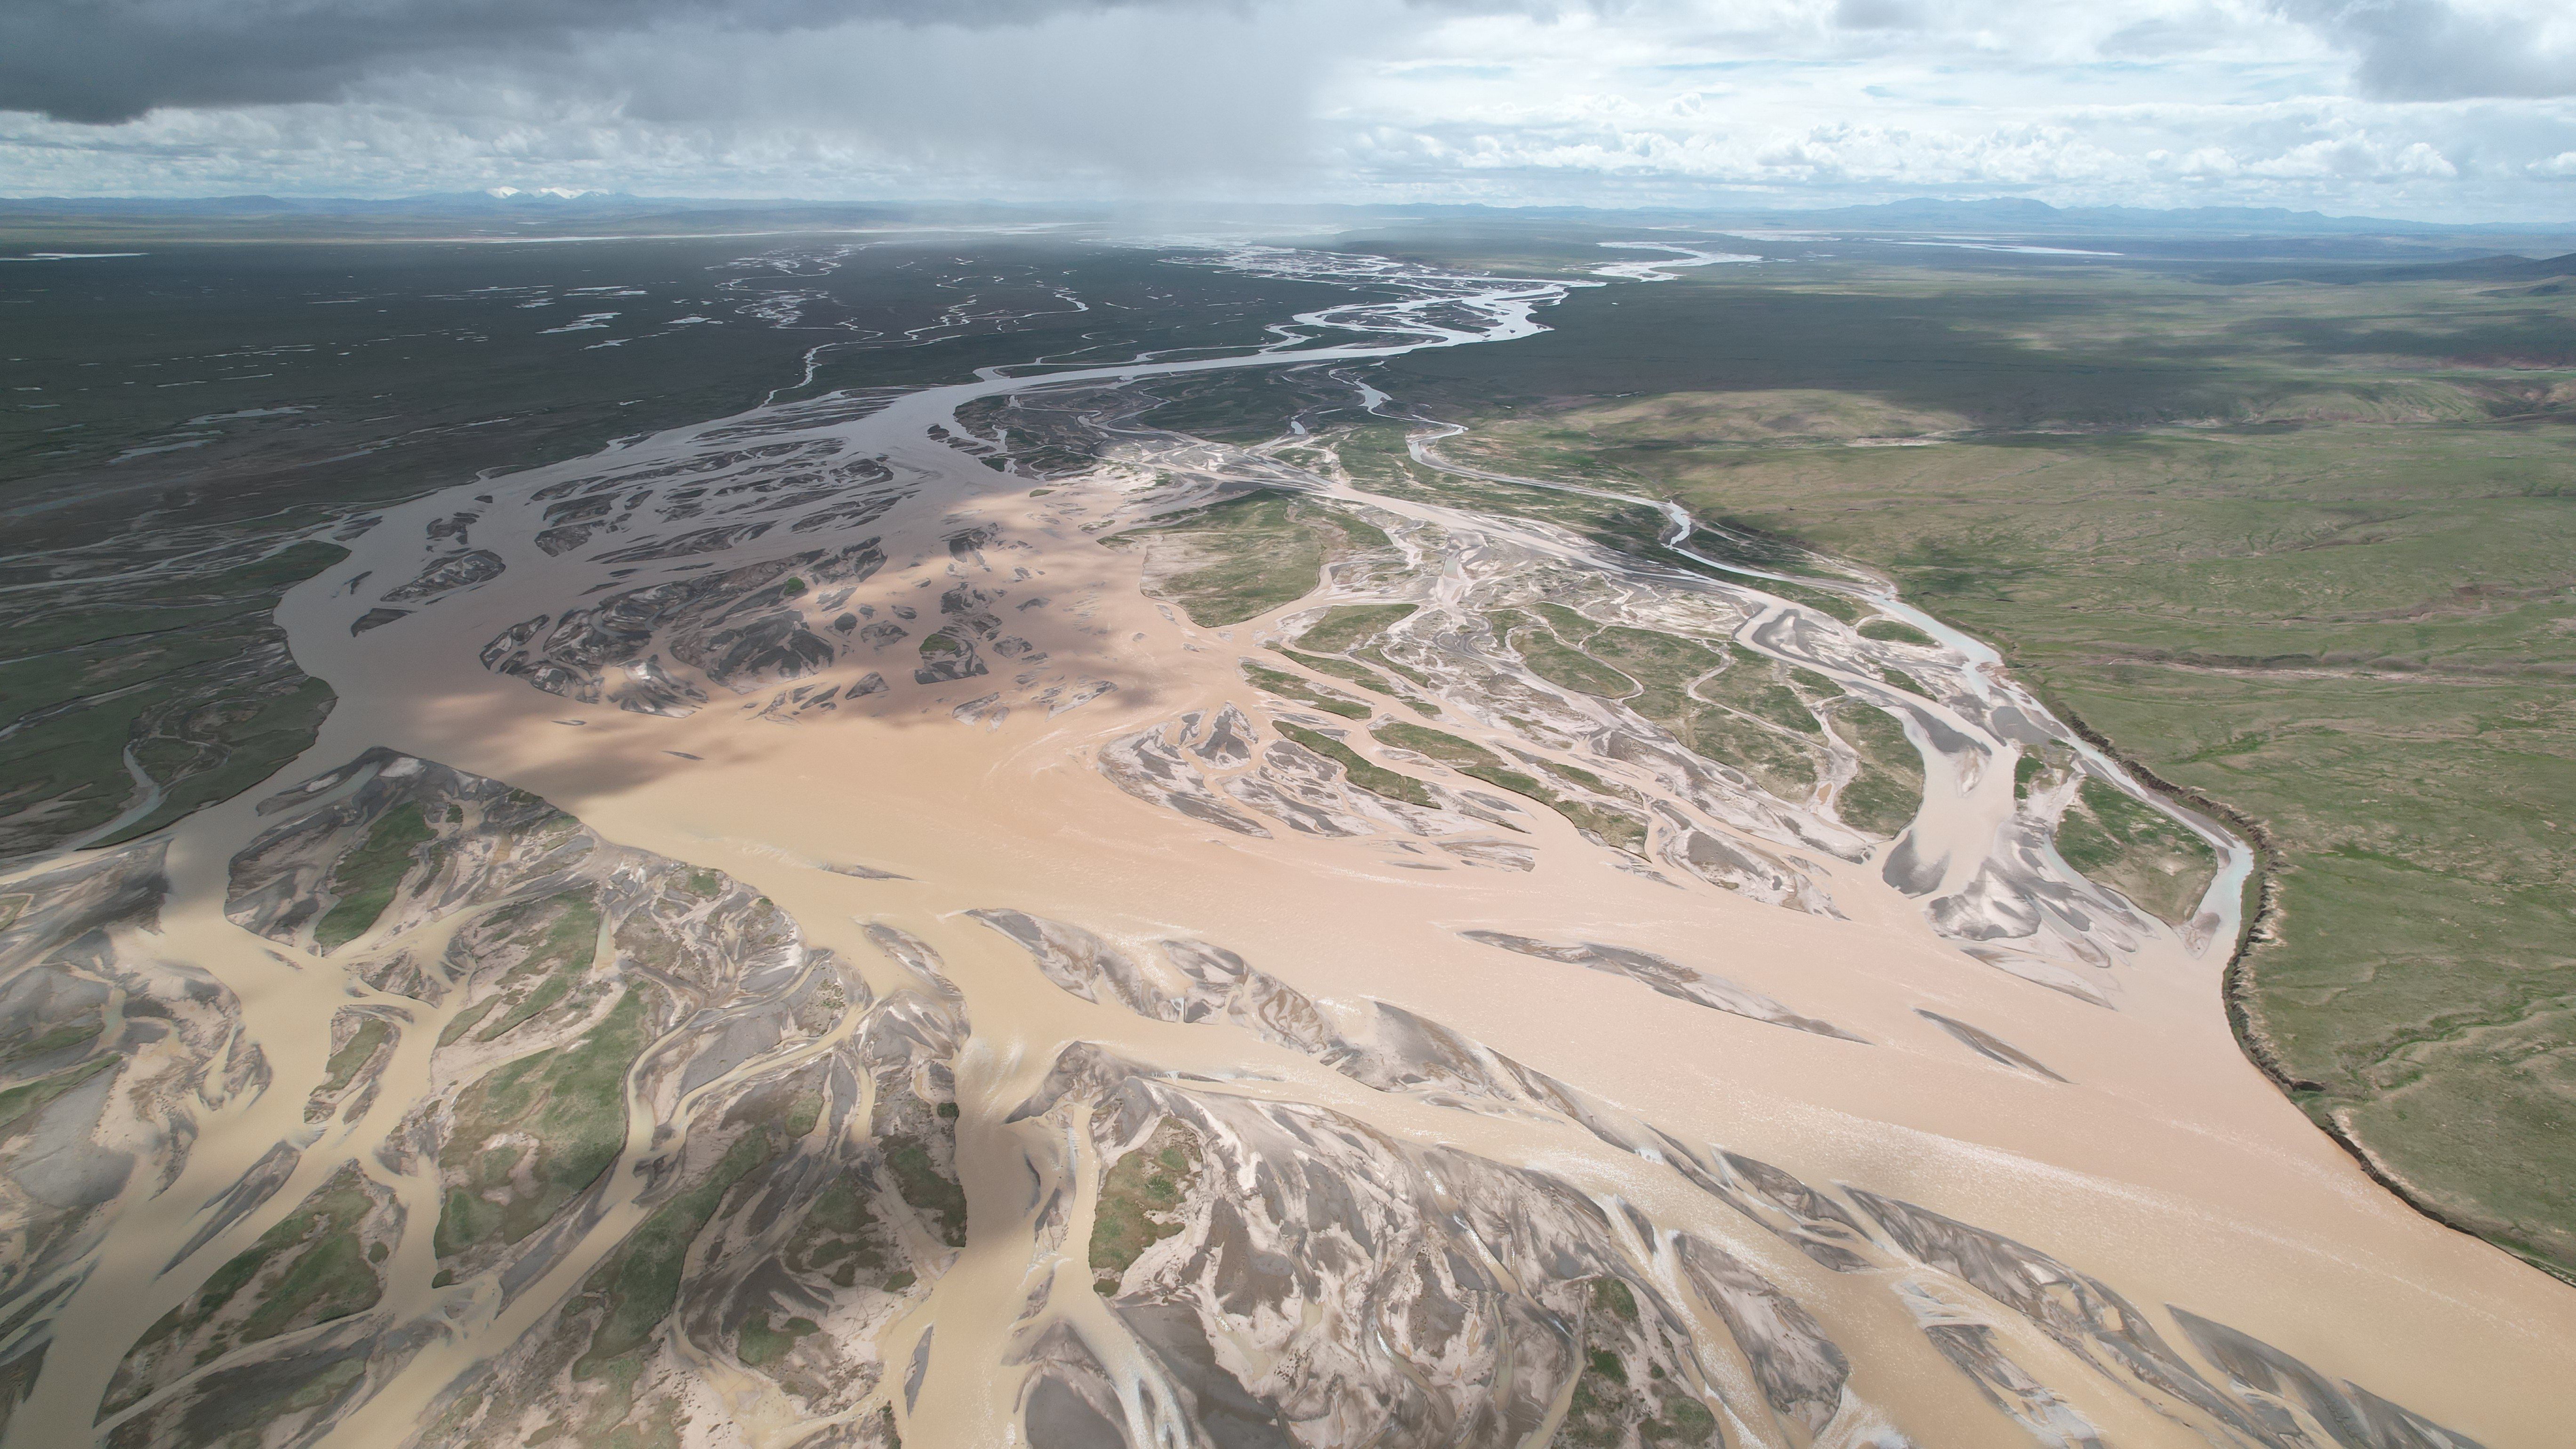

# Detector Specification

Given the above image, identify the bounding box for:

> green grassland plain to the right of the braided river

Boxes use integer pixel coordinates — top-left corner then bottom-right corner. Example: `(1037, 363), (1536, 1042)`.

(1381, 266), (2576, 1274)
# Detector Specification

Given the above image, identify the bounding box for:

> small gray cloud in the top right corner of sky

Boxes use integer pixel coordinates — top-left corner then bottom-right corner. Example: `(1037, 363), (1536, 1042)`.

(2275, 0), (2576, 101)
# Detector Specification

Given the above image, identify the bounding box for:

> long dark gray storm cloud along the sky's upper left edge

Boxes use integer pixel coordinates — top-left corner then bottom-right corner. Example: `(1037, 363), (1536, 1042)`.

(0, 0), (1185, 124)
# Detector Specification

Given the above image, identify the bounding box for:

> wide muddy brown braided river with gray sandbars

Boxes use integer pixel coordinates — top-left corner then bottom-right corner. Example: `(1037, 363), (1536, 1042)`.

(0, 250), (2576, 1449)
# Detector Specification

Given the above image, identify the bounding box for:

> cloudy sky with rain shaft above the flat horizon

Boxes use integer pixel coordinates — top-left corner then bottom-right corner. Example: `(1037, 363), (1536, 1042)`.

(0, 0), (2576, 224)
